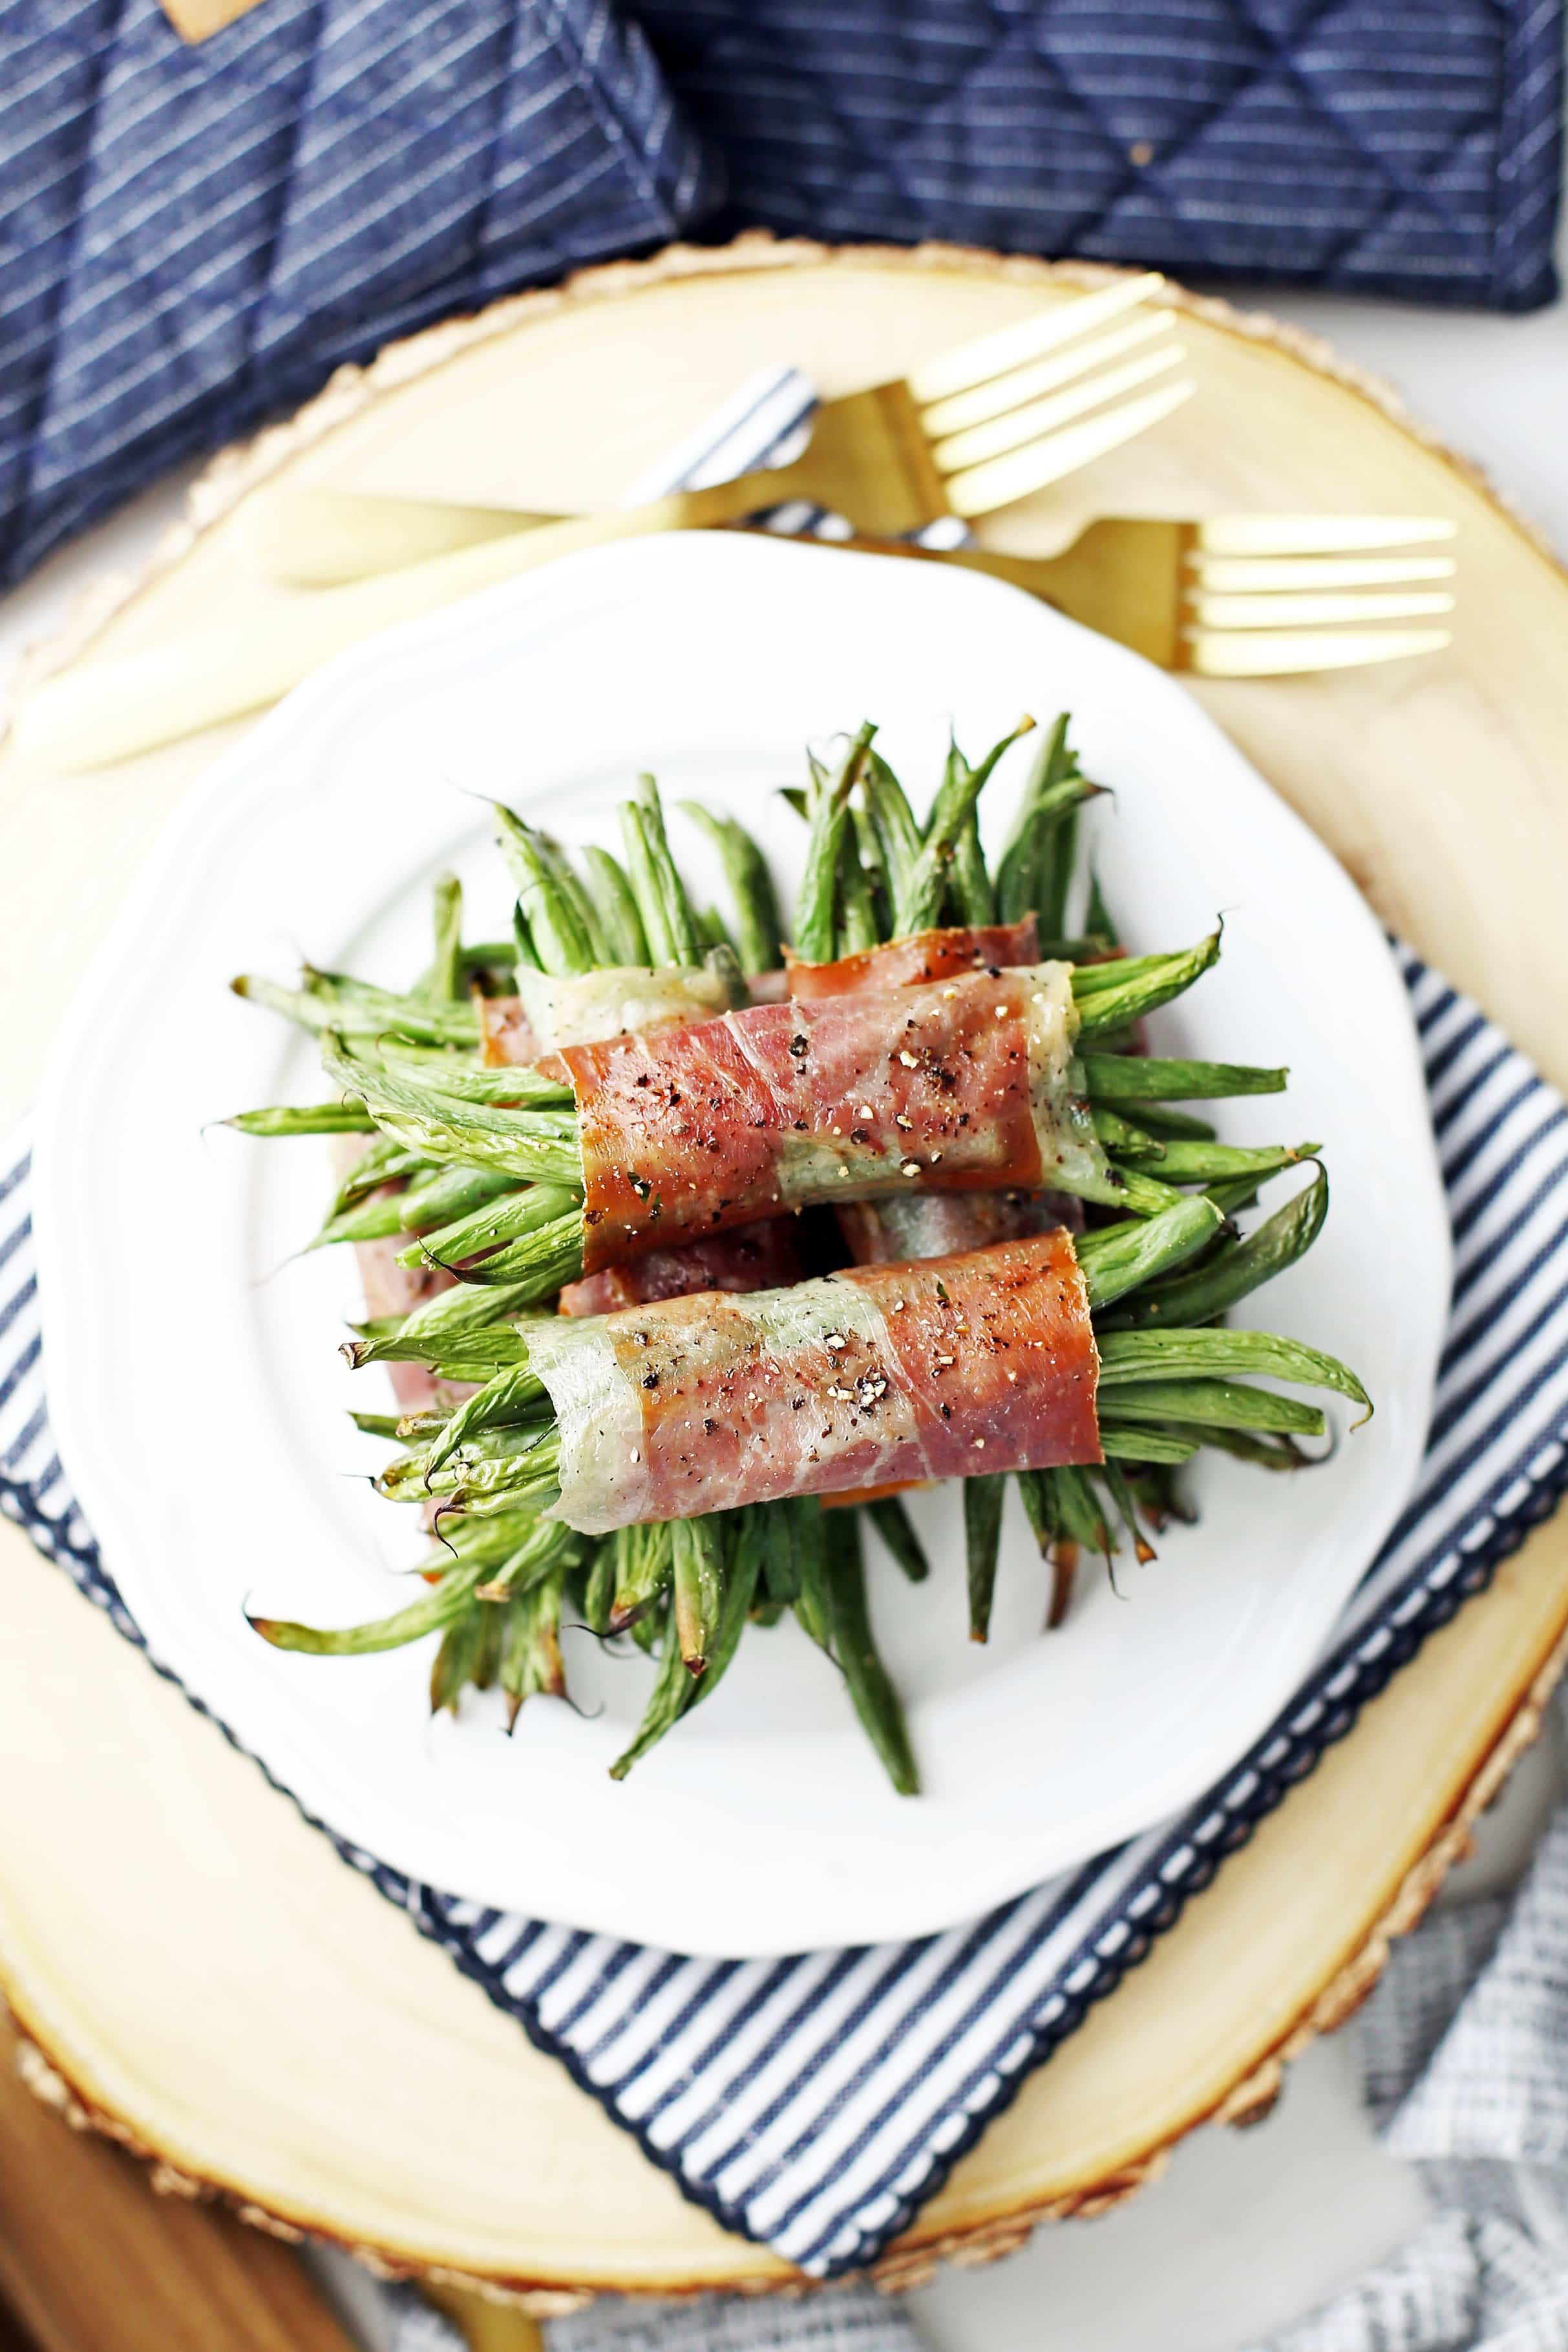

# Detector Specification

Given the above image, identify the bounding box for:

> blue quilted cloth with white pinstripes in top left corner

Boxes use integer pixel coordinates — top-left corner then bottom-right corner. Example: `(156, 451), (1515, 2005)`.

(0, 0), (722, 577)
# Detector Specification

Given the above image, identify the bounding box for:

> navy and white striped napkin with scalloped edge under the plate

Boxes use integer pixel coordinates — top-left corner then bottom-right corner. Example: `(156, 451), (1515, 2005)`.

(12, 953), (1568, 2277)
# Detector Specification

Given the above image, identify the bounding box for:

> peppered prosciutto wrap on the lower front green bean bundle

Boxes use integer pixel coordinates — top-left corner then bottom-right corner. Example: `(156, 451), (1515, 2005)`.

(527, 1233), (1103, 1536)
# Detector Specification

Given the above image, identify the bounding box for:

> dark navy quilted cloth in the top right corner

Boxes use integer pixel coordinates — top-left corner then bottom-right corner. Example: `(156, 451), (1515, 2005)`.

(635, 0), (1563, 310)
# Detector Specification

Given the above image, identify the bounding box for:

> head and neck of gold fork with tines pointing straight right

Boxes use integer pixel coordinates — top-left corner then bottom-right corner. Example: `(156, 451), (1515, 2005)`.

(832, 515), (1455, 677)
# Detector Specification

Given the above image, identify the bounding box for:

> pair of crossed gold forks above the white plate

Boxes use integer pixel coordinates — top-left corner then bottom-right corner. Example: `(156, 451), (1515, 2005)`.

(16, 273), (1455, 769)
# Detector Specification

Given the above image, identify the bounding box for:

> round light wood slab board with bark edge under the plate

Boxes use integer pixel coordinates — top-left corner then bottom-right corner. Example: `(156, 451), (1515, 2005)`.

(0, 240), (1568, 2307)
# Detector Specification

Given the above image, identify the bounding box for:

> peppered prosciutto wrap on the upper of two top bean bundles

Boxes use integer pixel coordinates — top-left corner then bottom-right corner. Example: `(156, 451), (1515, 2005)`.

(560, 964), (1117, 1273)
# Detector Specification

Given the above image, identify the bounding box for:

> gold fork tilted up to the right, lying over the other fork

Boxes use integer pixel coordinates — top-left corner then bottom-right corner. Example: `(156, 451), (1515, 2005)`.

(14, 273), (1192, 772)
